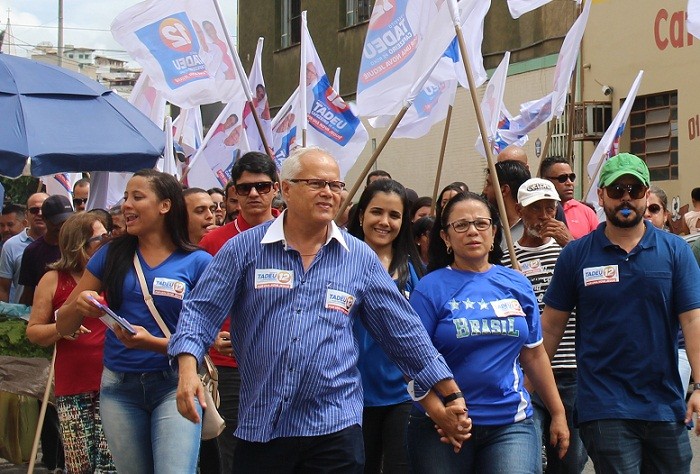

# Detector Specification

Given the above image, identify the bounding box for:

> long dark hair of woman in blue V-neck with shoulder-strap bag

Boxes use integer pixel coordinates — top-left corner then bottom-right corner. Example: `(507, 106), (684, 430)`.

(102, 169), (199, 309)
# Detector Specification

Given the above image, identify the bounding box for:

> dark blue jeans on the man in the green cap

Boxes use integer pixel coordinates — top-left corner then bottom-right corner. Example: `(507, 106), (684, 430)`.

(579, 420), (693, 474)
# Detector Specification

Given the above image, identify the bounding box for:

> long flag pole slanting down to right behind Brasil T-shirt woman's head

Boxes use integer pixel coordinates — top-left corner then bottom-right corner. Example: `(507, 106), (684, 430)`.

(448, 14), (520, 270)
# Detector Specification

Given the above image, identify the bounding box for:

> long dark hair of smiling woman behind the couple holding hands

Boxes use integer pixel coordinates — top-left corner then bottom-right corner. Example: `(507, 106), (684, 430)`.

(348, 179), (423, 291)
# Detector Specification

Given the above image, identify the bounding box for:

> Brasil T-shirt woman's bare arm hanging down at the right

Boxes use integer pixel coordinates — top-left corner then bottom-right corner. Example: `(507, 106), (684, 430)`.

(520, 344), (569, 458)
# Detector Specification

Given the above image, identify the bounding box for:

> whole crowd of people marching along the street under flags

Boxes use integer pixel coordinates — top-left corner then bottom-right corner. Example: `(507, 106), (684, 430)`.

(5, 147), (700, 474)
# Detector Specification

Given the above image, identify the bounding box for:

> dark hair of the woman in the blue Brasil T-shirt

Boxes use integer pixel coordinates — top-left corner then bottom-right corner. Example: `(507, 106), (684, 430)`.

(428, 191), (503, 273)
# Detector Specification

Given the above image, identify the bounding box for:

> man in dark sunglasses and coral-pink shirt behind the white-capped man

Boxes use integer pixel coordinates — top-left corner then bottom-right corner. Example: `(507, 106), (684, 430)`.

(540, 156), (598, 239)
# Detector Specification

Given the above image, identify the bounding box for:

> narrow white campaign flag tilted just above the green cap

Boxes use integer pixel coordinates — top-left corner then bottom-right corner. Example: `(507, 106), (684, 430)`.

(586, 71), (644, 204)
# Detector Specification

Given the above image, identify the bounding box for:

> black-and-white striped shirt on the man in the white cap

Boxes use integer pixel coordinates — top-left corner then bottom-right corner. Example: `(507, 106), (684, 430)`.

(502, 238), (576, 369)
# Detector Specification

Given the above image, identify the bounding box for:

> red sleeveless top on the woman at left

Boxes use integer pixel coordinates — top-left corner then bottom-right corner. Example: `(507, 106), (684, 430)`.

(51, 272), (107, 397)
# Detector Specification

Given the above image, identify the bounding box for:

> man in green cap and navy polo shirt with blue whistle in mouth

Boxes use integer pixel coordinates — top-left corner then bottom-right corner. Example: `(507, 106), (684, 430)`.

(542, 153), (700, 473)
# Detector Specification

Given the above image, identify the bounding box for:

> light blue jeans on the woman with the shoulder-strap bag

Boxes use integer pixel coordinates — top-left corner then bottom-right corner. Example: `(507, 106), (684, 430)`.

(100, 367), (201, 474)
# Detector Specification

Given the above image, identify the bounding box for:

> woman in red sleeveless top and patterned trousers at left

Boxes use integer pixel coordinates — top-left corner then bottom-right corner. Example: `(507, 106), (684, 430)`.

(27, 212), (116, 474)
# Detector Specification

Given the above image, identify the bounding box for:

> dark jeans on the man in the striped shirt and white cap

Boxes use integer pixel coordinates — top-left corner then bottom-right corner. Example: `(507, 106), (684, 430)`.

(532, 369), (588, 474)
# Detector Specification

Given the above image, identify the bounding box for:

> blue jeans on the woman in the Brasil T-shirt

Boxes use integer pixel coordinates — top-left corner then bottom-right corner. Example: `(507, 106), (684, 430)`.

(408, 409), (541, 474)
